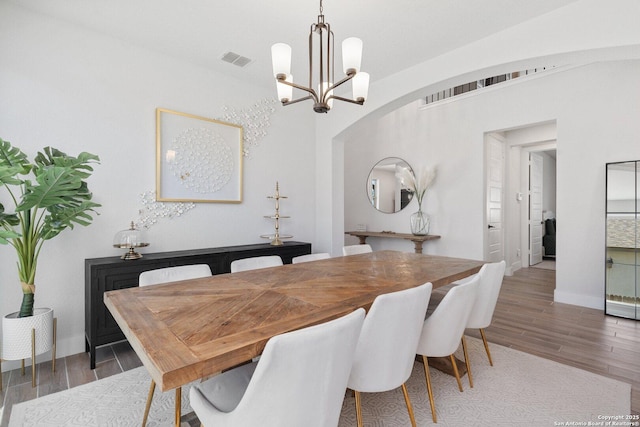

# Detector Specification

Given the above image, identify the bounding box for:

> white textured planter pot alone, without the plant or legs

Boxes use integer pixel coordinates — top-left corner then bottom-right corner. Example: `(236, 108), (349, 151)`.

(2, 308), (54, 364)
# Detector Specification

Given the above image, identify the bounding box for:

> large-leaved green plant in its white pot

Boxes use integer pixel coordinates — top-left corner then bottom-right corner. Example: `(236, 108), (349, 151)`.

(0, 139), (100, 384)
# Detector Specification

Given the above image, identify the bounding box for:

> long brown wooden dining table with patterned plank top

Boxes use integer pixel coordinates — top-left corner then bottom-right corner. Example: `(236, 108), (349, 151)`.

(104, 251), (484, 422)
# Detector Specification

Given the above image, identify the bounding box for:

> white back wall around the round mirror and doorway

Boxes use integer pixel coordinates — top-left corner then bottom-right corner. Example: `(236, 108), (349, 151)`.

(344, 61), (640, 308)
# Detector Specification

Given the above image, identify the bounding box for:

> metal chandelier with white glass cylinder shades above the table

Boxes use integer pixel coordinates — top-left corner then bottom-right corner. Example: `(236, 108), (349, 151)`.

(271, 0), (369, 113)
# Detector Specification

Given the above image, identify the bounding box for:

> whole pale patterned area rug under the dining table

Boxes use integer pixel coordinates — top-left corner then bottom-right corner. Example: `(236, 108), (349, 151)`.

(9, 338), (631, 427)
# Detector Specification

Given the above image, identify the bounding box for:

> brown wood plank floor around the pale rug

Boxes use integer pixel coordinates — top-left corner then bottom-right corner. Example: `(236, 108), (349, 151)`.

(0, 268), (640, 427)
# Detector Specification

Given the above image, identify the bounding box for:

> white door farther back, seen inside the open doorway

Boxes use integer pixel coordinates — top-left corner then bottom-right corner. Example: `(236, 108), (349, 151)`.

(529, 153), (543, 265)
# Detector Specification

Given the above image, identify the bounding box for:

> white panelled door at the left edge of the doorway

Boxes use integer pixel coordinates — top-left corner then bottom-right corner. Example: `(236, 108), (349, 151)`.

(485, 134), (504, 262)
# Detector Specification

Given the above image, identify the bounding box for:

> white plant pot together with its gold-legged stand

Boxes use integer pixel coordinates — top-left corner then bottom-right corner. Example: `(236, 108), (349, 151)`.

(0, 308), (58, 390)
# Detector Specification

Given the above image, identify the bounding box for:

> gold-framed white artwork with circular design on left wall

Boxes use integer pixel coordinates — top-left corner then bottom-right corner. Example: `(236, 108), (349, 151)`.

(156, 108), (243, 203)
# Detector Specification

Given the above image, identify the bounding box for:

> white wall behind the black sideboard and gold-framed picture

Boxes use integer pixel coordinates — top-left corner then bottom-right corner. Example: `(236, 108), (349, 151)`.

(0, 2), (315, 367)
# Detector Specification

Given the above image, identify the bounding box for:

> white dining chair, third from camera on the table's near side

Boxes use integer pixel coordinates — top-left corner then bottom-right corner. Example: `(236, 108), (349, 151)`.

(416, 276), (480, 423)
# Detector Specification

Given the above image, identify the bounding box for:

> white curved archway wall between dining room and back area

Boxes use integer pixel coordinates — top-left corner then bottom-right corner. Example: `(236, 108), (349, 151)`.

(316, 0), (640, 260)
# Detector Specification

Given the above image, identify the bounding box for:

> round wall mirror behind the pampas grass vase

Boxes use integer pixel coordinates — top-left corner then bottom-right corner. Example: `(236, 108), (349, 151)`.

(367, 157), (413, 213)
